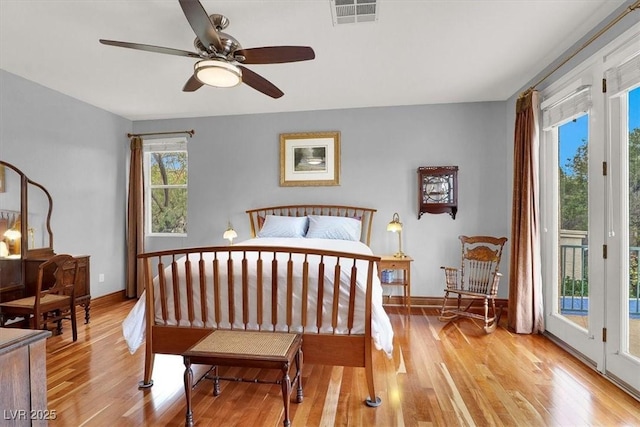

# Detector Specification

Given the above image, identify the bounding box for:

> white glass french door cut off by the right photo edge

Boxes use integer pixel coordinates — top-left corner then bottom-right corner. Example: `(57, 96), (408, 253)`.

(605, 49), (640, 394)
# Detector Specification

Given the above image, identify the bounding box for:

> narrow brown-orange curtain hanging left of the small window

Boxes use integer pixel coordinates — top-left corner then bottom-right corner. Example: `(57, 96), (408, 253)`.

(126, 136), (144, 298)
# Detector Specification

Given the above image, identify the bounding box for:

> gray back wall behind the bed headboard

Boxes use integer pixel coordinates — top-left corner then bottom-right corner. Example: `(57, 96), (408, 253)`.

(134, 102), (511, 297)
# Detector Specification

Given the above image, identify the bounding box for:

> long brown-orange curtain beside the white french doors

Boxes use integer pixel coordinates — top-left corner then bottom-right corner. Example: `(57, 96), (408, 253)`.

(509, 90), (544, 334)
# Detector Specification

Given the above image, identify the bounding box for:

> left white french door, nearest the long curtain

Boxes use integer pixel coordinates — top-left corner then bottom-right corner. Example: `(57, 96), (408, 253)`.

(541, 76), (605, 370)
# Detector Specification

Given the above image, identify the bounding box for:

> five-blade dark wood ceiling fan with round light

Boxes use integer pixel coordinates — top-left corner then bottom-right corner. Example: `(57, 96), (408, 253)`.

(100, 0), (315, 98)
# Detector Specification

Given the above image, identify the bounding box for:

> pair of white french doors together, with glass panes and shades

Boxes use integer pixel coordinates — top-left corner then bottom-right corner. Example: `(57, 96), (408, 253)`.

(540, 24), (640, 396)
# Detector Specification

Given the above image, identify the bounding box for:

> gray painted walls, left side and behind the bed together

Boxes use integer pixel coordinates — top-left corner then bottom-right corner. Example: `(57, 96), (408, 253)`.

(0, 67), (510, 296)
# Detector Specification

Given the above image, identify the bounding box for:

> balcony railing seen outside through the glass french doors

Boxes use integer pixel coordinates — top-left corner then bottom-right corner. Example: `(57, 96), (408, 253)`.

(560, 245), (640, 319)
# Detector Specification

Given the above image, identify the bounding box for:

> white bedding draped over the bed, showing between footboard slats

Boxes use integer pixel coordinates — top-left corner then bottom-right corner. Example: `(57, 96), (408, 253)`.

(122, 238), (393, 356)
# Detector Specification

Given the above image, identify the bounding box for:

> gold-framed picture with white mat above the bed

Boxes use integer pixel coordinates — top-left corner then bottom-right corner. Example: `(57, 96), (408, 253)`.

(280, 131), (340, 187)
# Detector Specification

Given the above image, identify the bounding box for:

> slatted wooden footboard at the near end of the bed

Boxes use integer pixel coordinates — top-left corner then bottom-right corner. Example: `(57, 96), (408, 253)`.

(139, 245), (381, 406)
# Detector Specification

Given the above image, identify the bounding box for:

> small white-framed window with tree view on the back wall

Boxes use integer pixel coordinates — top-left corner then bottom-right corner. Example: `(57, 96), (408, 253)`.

(144, 138), (188, 236)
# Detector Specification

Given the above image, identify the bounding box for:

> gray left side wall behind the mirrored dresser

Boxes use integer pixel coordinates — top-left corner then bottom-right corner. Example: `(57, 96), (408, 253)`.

(0, 70), (132, 297)
